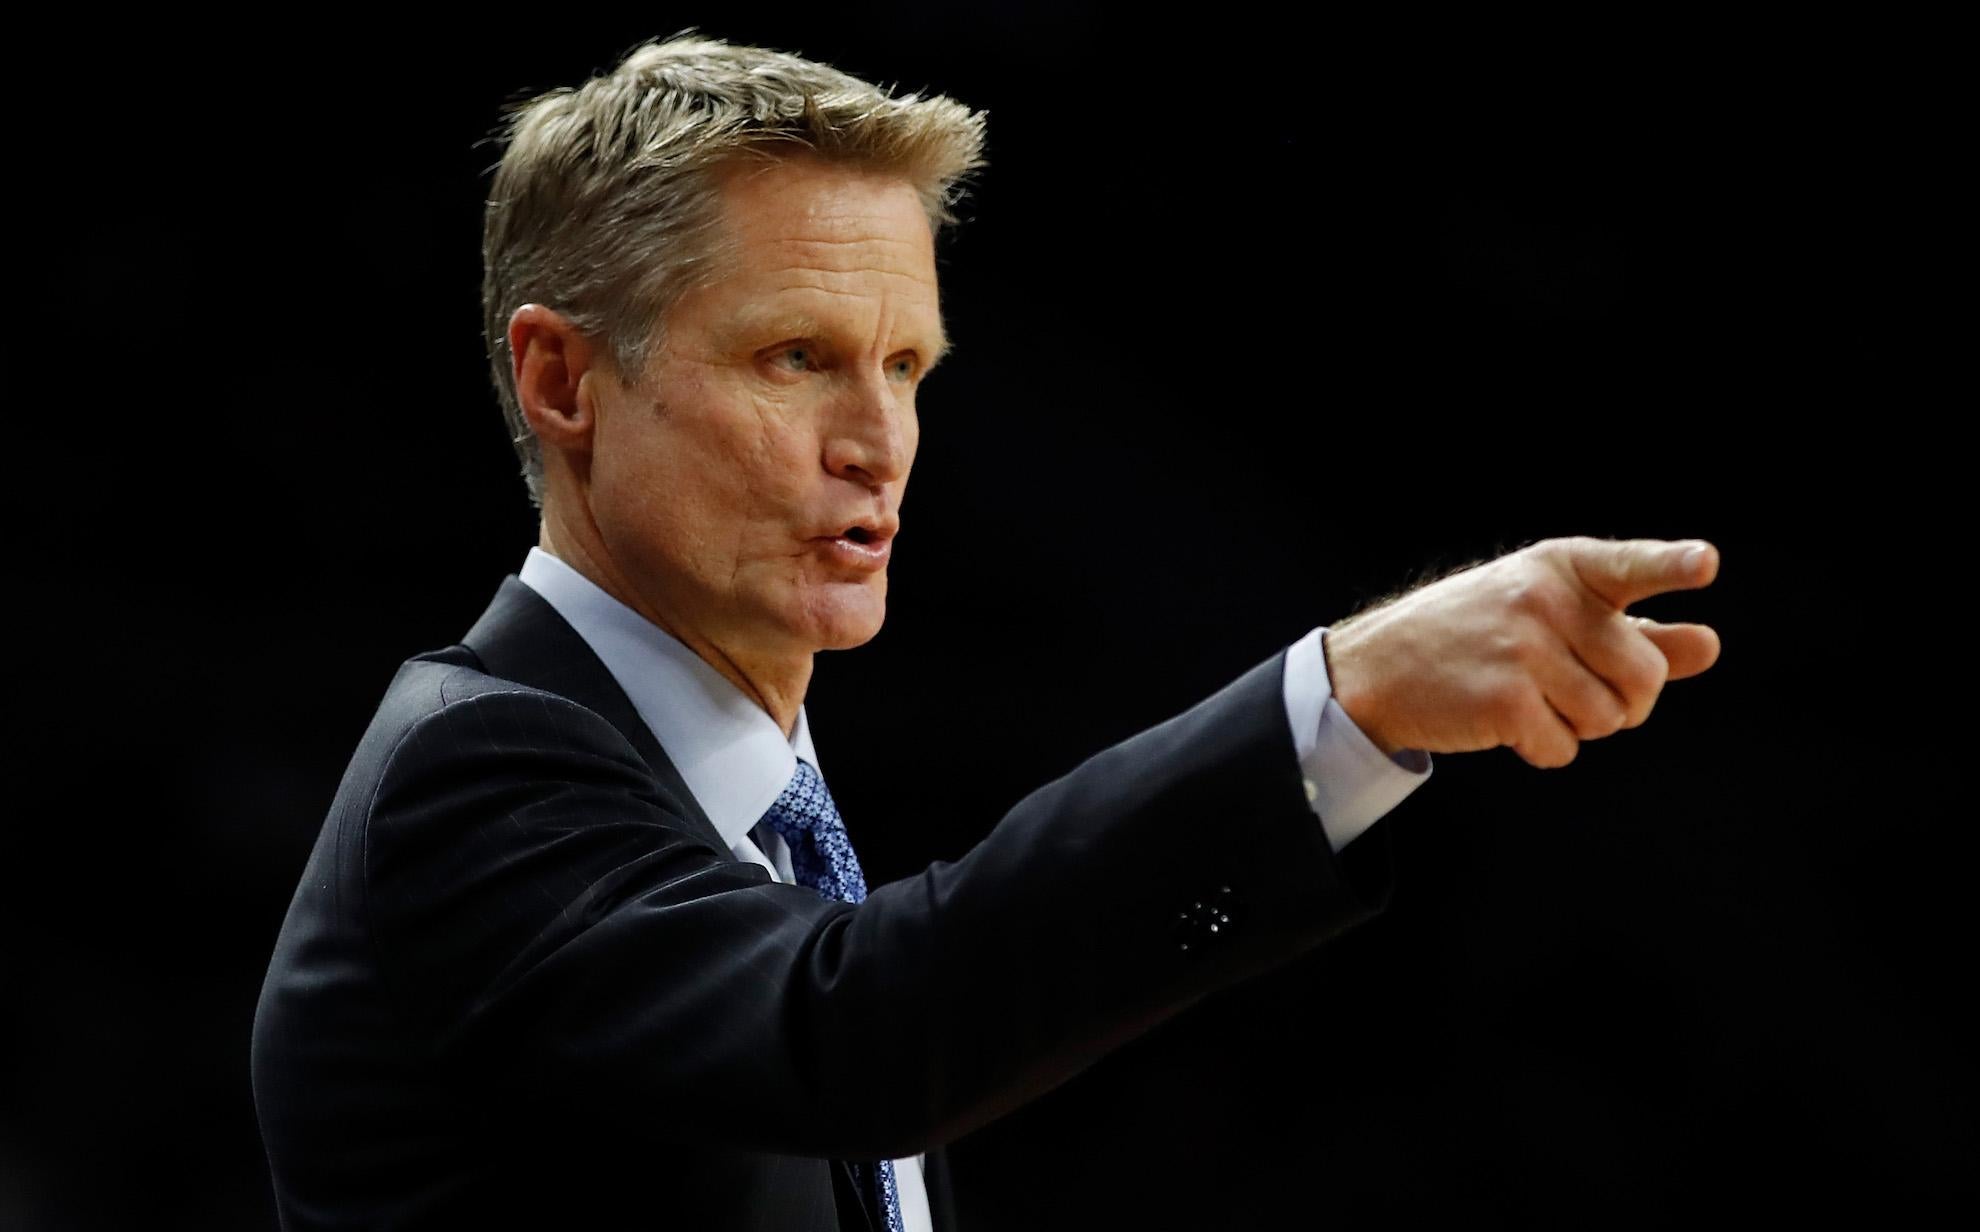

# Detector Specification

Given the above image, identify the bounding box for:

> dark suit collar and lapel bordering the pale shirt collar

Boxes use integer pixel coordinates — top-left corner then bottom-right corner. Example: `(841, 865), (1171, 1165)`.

(461, 574), (735, 858)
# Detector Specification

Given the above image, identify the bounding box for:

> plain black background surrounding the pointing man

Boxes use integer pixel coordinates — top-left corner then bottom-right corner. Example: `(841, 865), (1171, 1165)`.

(0, 6), (1976, 1230)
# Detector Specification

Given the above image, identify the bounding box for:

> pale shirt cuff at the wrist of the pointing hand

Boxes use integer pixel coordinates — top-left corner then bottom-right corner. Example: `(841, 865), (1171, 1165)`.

(1285, 626), (1432, 852)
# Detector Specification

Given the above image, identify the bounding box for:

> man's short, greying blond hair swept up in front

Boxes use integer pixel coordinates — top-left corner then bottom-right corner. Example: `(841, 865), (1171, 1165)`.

(481, 28), (986, 507)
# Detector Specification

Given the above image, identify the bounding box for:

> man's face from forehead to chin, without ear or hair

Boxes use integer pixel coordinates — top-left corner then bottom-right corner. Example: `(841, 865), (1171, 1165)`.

(592, 158), (946, 660)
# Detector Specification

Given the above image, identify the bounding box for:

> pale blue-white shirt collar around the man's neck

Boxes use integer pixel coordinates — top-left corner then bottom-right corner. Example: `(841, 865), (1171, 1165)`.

(519, 547), (822, 846)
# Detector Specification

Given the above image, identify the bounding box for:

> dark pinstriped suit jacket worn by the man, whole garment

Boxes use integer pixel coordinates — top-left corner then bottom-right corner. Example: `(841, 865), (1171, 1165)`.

(253, 576), (1388, 1232)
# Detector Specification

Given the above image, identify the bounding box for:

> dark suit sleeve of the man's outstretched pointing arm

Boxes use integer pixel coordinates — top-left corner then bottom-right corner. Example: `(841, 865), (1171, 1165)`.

(362, 652), (1390, 1159)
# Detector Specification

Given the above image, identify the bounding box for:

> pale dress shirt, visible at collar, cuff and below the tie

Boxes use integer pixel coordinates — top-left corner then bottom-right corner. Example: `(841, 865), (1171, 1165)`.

(521, 547), (1430, 1232)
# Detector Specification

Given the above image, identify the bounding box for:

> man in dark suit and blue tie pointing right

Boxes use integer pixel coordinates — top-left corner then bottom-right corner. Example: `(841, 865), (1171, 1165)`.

(253, 38), (1717, 1230)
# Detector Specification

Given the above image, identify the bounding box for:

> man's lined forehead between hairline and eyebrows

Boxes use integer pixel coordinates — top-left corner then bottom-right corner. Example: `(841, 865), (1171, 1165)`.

(683, 156), (941, 335)
